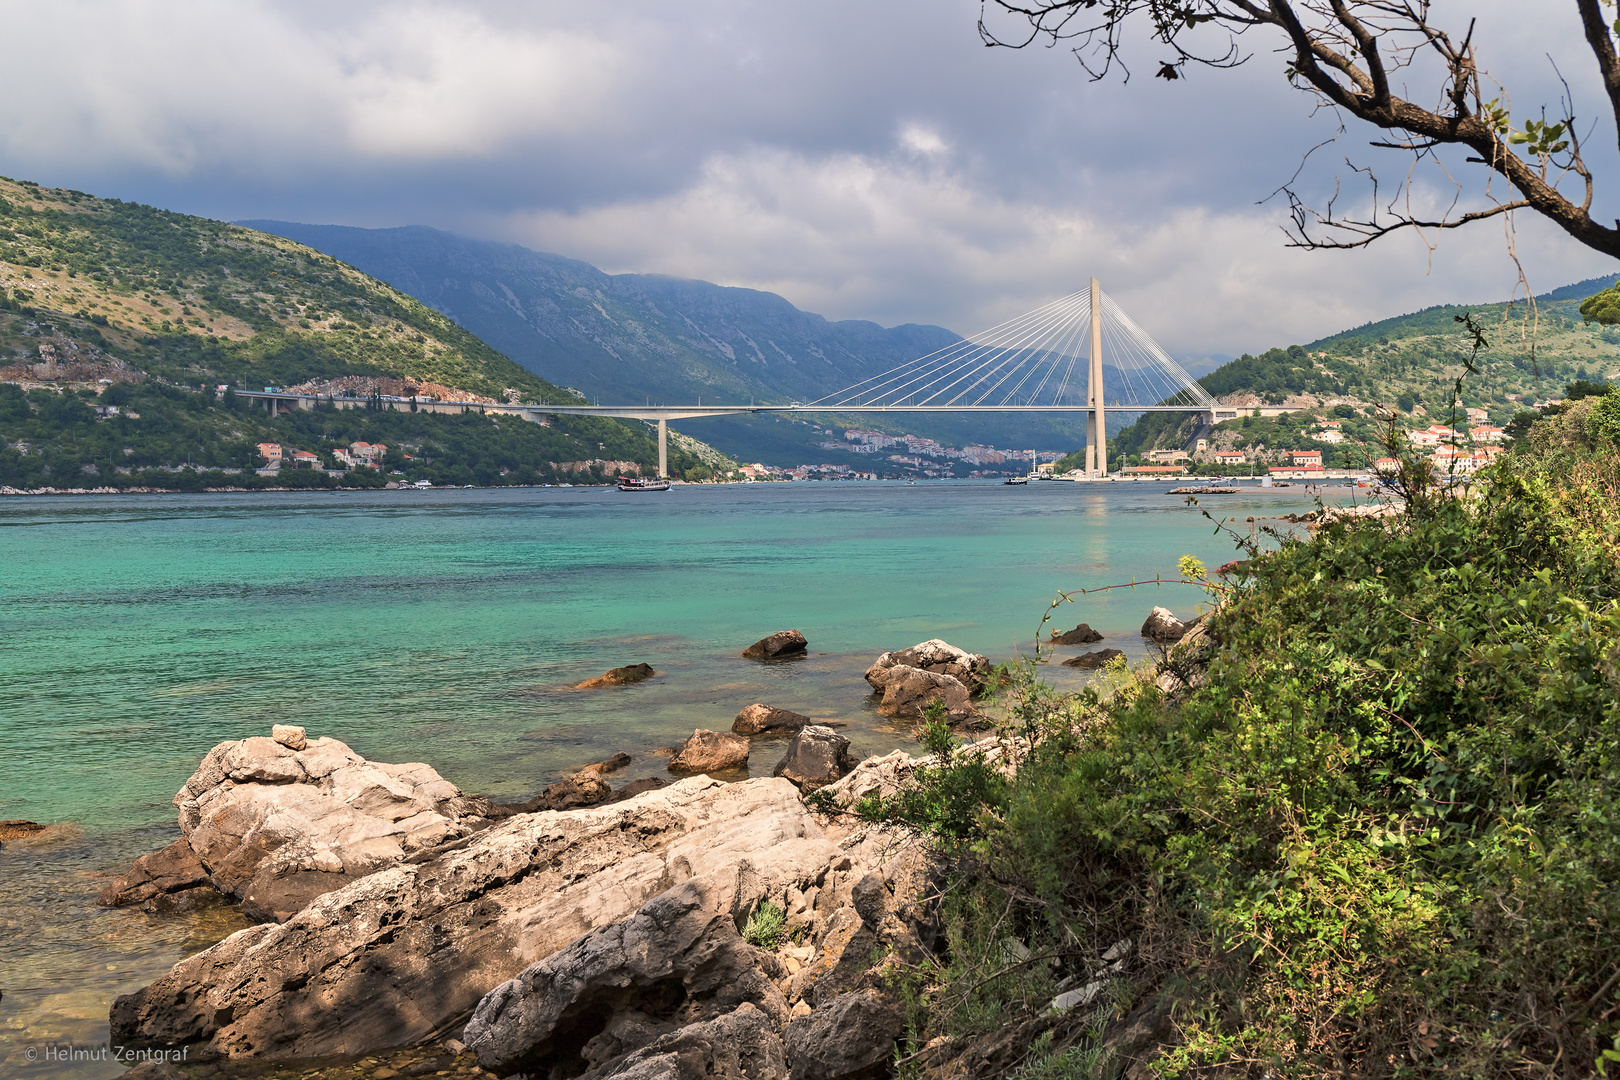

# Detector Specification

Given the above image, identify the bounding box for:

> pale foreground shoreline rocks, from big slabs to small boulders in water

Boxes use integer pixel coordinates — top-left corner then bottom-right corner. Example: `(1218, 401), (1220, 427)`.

(99, 625), (1205, 1080)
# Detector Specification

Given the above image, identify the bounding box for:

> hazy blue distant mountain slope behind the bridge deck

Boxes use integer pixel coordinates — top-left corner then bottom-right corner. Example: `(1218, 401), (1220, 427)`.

(241, 220), (1114, 465)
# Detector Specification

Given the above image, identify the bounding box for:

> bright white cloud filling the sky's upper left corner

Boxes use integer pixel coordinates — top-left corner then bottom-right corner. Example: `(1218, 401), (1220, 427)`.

(0, 0), (624, 176)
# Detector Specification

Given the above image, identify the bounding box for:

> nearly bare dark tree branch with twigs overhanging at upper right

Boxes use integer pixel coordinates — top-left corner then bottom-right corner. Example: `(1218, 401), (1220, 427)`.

(978, 0), (1620, 257)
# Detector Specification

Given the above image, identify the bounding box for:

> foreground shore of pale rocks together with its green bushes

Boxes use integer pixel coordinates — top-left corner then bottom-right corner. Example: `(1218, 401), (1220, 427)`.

(69, 383), (1620, 1080)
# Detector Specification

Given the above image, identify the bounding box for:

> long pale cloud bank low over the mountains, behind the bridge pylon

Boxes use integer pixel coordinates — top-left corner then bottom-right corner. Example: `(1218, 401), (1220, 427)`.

(492, 140), (1610, 356)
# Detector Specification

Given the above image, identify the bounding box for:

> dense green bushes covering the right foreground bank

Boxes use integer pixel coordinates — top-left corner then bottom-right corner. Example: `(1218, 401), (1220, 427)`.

(885, 453), (1620, 1077)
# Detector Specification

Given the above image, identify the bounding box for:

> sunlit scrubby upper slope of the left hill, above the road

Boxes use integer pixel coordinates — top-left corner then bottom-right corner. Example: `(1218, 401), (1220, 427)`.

(0, 180), (592, 402)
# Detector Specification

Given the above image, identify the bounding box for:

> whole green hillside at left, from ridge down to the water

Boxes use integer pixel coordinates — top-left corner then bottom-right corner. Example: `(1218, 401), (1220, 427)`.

(0, 180), (722, 487)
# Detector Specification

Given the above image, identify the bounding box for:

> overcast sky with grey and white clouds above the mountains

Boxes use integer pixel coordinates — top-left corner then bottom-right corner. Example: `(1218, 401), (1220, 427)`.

(0, 0), (1620, 358)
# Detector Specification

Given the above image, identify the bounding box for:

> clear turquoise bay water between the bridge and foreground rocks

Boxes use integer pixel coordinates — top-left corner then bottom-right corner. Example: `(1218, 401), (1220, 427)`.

(0, 481), (1341, 1077)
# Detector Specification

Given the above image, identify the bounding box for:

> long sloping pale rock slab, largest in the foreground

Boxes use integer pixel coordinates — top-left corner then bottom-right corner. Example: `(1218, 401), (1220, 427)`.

(112, 777), (842, 1061)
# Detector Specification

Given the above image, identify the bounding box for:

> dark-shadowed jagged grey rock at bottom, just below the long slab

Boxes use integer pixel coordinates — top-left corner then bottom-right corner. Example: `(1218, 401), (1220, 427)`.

(462, 881), (787, 1075)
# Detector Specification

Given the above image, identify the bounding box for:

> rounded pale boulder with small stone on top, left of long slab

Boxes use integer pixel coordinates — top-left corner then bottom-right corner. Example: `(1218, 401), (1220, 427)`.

(175, 737), (486, 921)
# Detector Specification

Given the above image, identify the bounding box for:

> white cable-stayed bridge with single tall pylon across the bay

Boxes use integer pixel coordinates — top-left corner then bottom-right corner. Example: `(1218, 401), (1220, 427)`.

(246, 279), (1236, 476)
